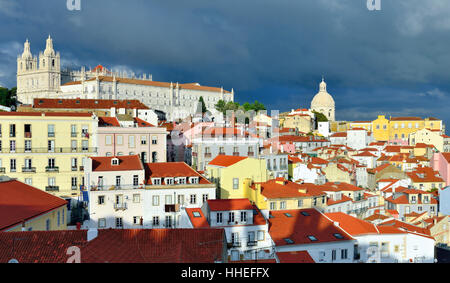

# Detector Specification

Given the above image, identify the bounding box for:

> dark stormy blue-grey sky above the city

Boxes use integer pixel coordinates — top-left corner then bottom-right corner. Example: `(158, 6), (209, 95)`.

(0, 0), (450, 124)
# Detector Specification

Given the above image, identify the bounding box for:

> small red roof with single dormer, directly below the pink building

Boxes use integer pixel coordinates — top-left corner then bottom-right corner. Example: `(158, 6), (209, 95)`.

(89, 155), (144, 172)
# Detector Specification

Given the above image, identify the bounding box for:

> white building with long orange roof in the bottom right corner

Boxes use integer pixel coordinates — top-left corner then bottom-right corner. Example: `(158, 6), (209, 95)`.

(326, 213), (435, 263)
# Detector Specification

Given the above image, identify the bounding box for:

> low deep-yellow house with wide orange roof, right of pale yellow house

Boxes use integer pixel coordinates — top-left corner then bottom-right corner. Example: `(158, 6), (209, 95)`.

(244, 178), (327, 211)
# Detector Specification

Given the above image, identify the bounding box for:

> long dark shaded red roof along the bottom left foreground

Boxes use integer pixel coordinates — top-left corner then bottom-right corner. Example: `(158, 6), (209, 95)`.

(0, 228), (225, 263)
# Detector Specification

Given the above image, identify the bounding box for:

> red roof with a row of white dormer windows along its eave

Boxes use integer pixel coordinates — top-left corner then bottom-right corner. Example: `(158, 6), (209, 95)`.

(144, 162), (211, 185)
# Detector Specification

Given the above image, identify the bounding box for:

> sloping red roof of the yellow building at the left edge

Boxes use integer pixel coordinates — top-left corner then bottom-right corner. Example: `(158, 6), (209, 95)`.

(0, 180), (67, 231)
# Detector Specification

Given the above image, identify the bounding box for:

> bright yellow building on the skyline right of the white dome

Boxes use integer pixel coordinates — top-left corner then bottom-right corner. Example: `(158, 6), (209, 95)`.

(372, 115), (443, 145)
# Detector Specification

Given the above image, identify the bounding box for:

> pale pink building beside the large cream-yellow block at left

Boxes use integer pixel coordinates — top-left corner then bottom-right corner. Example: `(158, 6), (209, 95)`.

(97, 117), (167, 163)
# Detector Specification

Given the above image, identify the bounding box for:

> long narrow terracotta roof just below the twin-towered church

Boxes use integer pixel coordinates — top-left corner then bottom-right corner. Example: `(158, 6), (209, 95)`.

(33, 98), (150, 109)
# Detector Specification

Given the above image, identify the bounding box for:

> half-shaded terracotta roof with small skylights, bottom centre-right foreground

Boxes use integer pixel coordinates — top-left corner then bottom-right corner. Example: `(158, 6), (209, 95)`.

(269, 209), (353, 246)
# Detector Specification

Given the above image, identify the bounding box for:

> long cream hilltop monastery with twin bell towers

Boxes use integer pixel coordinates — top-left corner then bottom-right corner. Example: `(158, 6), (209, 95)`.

(17, 36), (234, 120)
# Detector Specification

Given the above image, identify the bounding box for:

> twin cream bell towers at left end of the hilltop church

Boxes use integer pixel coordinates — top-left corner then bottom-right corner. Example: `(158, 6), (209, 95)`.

(17, 36), (61, 104)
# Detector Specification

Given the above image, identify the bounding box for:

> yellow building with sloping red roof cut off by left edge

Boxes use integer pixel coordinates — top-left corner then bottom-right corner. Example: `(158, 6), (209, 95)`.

(0, 176), (68, 232)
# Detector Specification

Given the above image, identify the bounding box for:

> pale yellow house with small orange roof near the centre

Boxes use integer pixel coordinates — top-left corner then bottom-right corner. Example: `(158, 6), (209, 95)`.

(205, 155), (268, 199)
